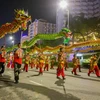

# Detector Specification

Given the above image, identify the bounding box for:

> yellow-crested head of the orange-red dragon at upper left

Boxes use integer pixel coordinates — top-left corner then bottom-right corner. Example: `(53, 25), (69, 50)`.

(15, 10), (31, 30)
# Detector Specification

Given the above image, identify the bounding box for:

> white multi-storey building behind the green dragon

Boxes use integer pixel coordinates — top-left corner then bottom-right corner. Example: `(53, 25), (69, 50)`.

(21, 19), (56, 42)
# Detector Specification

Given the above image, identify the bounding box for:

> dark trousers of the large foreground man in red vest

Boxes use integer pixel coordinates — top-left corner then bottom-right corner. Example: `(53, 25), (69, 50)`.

(14, 63), (21, 82)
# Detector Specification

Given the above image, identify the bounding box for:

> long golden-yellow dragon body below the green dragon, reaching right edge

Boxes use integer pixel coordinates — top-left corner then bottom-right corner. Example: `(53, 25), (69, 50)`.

(29, 39), (100, 54)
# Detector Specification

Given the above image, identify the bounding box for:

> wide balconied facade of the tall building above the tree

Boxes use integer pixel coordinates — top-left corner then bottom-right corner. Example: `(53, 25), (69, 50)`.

(67, 0), (100, 18)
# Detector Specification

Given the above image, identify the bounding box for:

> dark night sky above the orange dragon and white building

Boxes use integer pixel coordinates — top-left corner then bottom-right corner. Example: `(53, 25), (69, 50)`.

(0, 0), (59, 46)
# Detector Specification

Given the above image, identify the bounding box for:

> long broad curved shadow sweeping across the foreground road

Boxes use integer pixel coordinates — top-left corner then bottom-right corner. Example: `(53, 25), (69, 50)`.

(15, 83), (80, 100)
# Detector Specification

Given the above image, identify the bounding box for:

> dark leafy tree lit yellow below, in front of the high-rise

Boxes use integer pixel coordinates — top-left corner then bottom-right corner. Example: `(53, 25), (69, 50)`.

(70, 14), (100, 41)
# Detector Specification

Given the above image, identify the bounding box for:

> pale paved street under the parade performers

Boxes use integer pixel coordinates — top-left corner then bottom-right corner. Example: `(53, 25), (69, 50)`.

(0, 69), (100, 100)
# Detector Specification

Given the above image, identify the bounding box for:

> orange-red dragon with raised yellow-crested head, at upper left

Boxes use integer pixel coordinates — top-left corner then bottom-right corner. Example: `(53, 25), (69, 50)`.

(0, 10), (31, 38)
